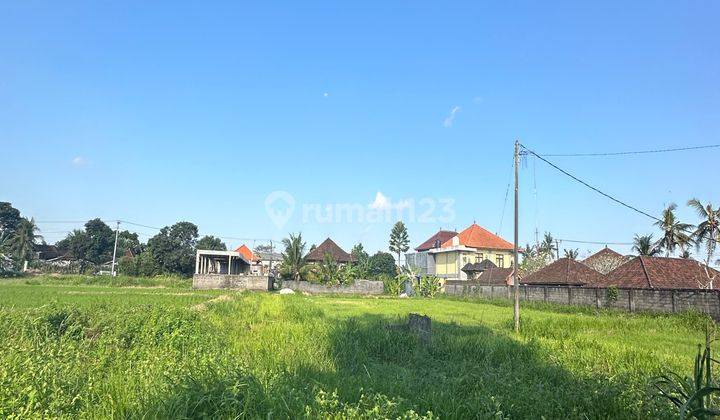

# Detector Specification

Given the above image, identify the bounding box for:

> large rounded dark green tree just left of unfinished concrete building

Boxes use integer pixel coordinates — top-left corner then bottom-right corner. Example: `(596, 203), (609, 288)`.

(148, 222), (198, 277)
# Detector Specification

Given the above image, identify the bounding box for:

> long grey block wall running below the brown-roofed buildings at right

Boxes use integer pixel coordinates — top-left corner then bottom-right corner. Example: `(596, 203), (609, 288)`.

(445, 282), (720, 320)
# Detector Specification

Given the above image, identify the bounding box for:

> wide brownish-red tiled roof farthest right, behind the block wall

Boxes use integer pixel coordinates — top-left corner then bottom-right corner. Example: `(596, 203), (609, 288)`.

(597, 256), (720, 289)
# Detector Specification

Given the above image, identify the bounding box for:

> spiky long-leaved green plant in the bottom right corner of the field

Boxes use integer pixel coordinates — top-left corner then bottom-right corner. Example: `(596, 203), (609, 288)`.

(653, 330), (720, 419)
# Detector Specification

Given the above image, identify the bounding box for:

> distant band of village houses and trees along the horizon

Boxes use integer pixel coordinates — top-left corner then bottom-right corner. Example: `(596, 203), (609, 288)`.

(0, 199), (720, 289)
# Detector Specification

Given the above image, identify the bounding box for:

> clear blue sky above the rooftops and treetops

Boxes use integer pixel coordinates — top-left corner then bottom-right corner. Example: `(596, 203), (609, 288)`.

(0, 1), (720, 260)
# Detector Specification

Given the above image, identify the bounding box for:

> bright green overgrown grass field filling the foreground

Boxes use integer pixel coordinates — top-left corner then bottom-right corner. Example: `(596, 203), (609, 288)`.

(0, 277), (706, 418)
